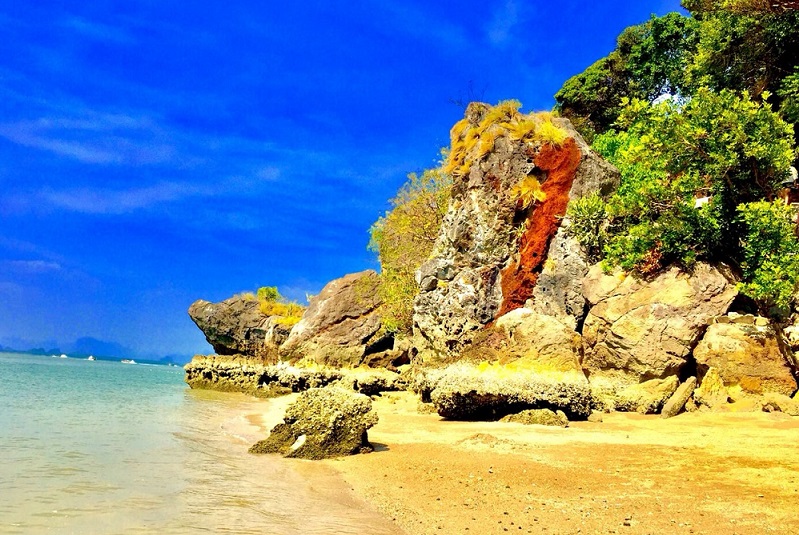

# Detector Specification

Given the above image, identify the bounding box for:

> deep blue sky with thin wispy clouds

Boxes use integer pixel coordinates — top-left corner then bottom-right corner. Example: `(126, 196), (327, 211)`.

(0, 0), (679, 355)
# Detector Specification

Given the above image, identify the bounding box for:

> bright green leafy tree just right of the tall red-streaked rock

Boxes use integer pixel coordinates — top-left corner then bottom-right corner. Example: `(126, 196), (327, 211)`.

(594, 88), (794, 273)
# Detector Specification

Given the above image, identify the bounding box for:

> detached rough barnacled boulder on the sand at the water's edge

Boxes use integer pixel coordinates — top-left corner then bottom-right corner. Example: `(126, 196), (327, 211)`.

(250, 387), (377, 459)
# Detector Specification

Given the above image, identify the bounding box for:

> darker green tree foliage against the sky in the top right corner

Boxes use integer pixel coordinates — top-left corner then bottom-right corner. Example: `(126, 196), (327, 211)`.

(555, 7), (799, 139)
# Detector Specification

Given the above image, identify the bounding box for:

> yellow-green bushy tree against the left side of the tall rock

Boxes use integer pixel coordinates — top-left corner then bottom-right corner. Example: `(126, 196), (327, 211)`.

(369, 169), (451, 334)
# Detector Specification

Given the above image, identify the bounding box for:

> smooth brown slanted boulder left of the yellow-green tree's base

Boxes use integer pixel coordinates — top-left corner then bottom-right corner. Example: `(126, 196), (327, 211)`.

(280, 270), (393, 368)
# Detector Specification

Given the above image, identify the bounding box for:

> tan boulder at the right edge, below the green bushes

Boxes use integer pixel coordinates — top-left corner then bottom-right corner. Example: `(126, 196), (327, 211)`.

(694, 323), (797, 396)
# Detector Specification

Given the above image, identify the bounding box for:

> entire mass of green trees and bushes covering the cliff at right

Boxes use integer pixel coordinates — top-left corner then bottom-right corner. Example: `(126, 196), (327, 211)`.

(556, 1), (799, 316)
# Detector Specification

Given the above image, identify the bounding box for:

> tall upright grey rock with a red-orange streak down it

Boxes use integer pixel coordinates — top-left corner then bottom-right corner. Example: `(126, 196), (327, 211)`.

(414, 103), (619, 364)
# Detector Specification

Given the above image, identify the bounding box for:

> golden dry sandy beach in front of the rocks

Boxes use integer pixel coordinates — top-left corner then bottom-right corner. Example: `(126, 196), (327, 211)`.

(304, 393), (799, 535)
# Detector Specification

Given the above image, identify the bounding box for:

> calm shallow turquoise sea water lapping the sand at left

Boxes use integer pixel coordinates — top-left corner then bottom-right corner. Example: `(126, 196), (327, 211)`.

(0, 353), (398, 535)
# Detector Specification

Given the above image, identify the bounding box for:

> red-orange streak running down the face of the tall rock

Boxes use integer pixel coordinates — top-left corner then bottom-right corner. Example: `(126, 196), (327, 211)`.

(497, 138), (582, 317)
